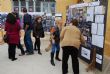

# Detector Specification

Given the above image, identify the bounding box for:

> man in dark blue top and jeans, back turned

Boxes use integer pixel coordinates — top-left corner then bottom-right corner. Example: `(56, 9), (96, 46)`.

(23, 8), (34, 55)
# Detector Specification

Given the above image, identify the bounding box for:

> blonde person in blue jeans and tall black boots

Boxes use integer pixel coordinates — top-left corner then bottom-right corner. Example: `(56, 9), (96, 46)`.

(50, 25), (61, 66)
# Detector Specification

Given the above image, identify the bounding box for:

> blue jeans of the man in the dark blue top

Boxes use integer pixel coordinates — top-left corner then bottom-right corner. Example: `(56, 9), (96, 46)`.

(24, 30), (33, 53)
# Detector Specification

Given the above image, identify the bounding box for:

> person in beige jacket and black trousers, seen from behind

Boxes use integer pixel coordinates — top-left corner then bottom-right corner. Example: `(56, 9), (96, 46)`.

(60, 19), (85, 74)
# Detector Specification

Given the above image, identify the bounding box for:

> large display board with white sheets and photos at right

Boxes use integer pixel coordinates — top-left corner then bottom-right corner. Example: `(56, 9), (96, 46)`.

(68, 0), (107, 70)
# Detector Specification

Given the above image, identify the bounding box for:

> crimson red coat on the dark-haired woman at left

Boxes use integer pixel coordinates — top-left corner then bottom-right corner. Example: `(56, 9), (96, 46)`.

(5, 22), (21, 44)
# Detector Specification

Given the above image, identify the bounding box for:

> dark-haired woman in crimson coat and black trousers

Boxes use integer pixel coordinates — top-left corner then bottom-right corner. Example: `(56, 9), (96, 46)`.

(5, 13), (20, 61)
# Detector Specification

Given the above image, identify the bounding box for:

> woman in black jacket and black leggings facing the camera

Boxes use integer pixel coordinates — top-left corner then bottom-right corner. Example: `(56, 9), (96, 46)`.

(33, 16), (44, 55)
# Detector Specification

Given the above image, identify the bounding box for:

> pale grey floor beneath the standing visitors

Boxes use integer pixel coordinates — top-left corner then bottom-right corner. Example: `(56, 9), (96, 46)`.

(0, 40), (94, 74)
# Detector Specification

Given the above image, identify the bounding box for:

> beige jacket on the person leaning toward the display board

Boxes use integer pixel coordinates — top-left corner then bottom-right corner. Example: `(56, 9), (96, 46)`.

(60, 26), (85, 49)
